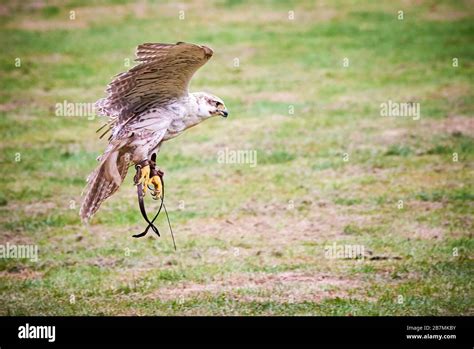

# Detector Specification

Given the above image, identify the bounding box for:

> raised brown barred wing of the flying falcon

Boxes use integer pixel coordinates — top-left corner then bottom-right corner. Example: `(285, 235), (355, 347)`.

(96, 42), (213, 124)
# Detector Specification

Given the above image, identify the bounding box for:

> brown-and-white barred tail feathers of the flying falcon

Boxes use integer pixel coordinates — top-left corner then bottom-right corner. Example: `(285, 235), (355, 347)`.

(79, 150), (129, 222)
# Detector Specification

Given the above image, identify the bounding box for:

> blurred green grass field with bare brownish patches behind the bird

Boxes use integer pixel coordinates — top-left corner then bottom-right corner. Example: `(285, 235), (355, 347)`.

(0, 0), (474, 315)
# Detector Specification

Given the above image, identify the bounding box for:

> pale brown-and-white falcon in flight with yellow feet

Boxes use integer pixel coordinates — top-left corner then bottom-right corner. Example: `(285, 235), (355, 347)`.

(80, 42), (228, 222)
